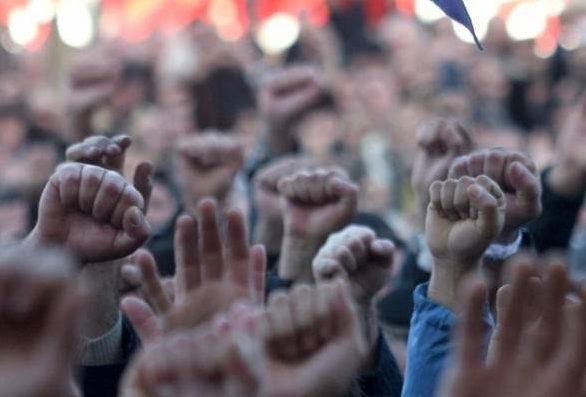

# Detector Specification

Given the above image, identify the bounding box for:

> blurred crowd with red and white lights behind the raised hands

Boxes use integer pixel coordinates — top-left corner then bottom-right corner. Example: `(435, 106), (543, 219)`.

(0, 0), (586, 248)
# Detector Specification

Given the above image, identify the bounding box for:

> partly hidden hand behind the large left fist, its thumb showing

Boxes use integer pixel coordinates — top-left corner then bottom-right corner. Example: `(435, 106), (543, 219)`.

(65, 135), (153, 212)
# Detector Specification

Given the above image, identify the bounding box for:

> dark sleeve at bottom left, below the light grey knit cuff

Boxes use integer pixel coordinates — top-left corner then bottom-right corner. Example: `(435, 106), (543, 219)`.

(78, 317), (140, 397)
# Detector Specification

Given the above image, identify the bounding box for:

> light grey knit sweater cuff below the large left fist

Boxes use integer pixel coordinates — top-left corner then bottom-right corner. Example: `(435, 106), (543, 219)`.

(78, 316), (123, 366)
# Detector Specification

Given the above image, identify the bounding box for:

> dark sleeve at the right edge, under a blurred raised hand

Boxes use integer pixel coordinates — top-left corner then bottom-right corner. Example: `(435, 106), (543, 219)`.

(527, 168), (584, 252)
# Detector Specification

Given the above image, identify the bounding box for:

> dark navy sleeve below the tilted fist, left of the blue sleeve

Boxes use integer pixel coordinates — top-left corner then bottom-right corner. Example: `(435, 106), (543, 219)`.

(357, 333), (403, 397)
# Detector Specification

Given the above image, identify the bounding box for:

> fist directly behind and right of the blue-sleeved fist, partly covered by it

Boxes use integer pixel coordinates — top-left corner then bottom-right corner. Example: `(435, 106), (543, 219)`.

(449, 149), (542, 243)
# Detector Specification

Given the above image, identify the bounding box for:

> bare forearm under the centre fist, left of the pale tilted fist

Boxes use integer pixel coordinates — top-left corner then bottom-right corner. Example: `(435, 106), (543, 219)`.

(279, 236), (322, 283)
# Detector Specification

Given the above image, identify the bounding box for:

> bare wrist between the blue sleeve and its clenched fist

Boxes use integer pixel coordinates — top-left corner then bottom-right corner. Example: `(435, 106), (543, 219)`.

(427, 258), (481, 313)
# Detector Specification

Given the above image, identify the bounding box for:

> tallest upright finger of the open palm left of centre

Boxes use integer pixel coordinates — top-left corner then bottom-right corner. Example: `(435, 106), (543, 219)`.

(198, 199), (225, 281)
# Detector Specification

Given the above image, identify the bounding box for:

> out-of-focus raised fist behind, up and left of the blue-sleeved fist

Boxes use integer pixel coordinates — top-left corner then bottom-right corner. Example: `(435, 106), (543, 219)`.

(411, 118), (474, 225)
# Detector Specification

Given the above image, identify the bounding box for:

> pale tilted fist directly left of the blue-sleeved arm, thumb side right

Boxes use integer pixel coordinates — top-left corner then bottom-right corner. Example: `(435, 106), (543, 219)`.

(313, 225), (395, 302)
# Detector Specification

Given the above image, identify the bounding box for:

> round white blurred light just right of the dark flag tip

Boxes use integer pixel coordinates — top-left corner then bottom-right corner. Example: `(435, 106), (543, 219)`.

(506, 2), (547, 40)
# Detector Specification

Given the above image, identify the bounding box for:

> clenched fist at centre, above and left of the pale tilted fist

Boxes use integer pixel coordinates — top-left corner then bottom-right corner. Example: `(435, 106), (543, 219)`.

(278, 170), (358, 240)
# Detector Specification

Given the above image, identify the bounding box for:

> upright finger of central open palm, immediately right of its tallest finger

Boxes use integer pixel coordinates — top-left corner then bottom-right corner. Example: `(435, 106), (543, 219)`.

(226, 210), (252, 290)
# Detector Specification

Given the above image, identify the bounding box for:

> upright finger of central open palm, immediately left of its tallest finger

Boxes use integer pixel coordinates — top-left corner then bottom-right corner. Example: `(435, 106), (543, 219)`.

(174, 214), (201, 299)
